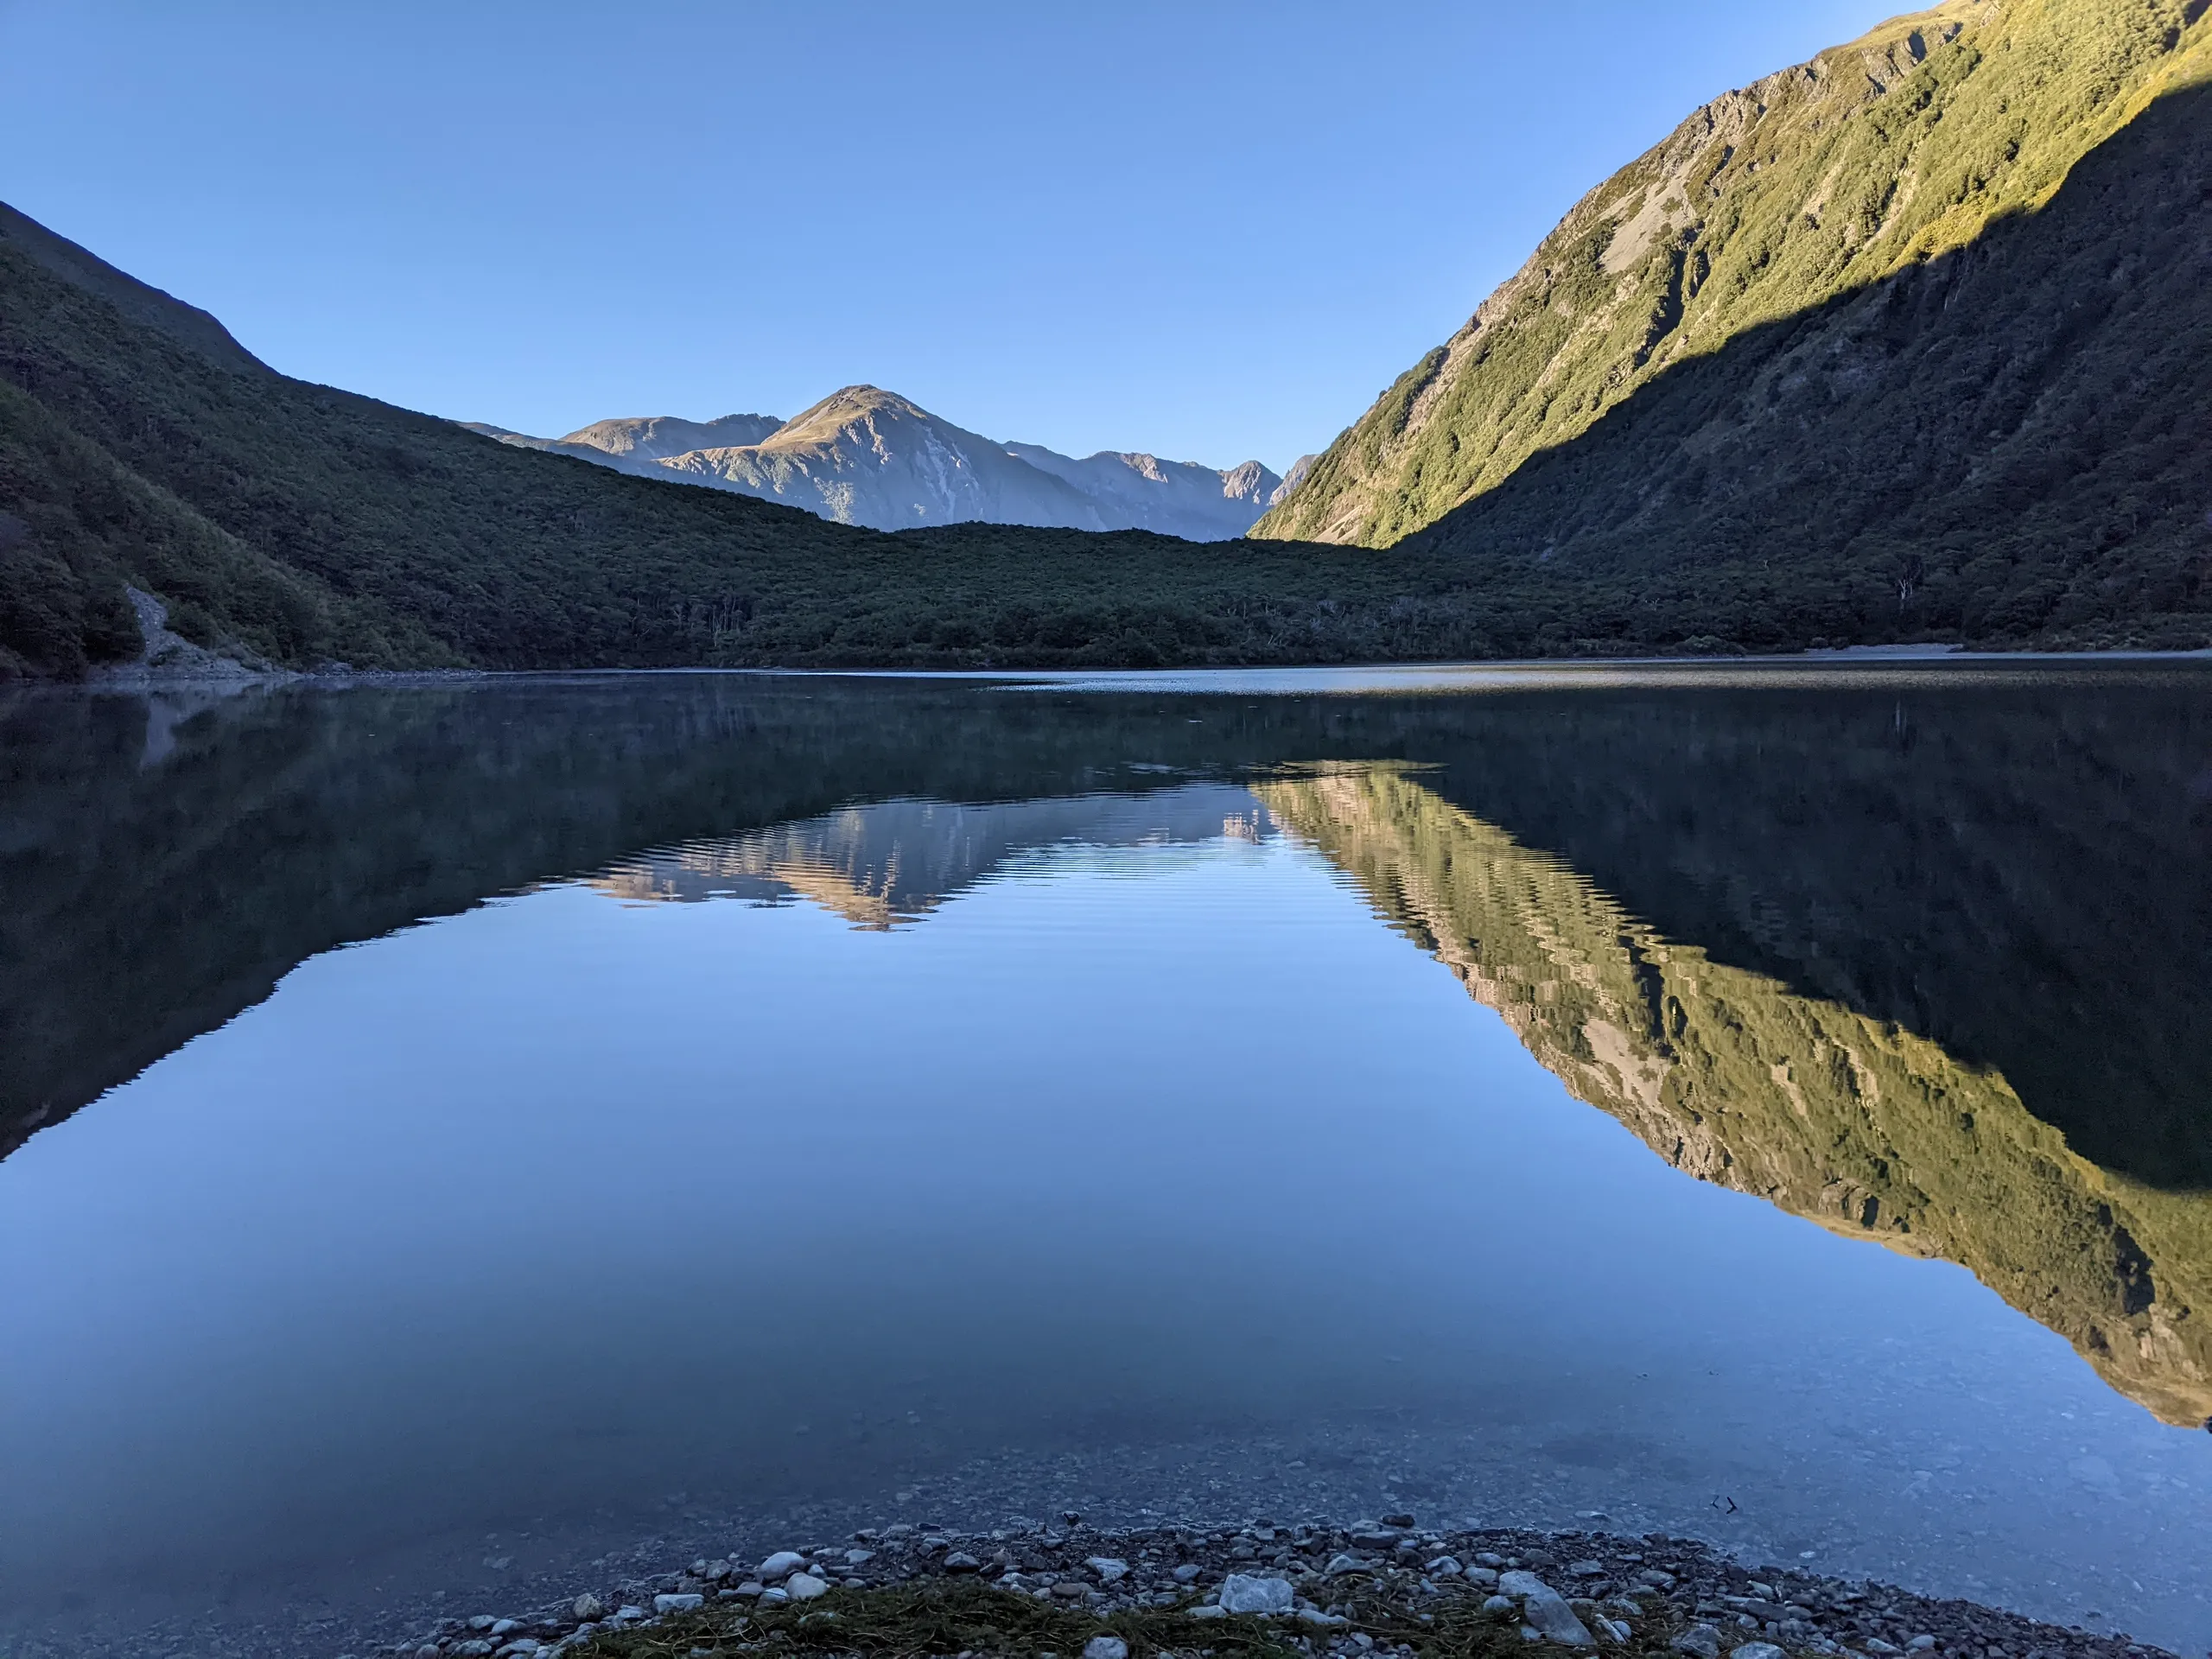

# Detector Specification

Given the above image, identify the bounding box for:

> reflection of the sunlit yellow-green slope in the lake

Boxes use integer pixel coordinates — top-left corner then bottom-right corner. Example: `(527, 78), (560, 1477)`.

(1255, 767), (2212, 1427)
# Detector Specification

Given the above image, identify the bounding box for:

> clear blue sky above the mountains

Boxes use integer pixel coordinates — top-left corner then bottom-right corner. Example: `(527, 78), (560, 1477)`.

(0, 0), (1897, 469)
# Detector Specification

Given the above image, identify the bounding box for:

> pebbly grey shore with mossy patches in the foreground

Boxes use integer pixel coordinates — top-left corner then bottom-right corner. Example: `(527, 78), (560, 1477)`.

(362, 1513), (2165, 1659)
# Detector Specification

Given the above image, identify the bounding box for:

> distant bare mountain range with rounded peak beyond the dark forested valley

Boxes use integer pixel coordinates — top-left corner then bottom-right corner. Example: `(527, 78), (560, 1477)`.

(462, 385), (1312, 542)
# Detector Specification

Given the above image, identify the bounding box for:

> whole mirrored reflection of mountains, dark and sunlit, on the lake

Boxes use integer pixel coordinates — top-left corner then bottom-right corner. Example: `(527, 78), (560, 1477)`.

(0, 668), (2212, 1421)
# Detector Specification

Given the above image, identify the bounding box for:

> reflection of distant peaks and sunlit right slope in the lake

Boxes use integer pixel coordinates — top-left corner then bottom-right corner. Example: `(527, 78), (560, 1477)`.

(557, 761), (2212, 1427)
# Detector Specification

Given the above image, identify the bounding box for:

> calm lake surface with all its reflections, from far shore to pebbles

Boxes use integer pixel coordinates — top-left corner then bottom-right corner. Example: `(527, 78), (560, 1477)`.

(0, 664), (2212, 1656)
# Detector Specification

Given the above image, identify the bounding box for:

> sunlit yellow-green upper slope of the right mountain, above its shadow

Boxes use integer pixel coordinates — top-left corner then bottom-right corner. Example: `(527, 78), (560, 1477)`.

(1259, 0), (2212, 546)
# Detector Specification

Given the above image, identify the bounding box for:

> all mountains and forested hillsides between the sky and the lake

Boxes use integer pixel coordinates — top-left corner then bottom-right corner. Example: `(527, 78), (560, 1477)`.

(0, 0), (2212, 677)
